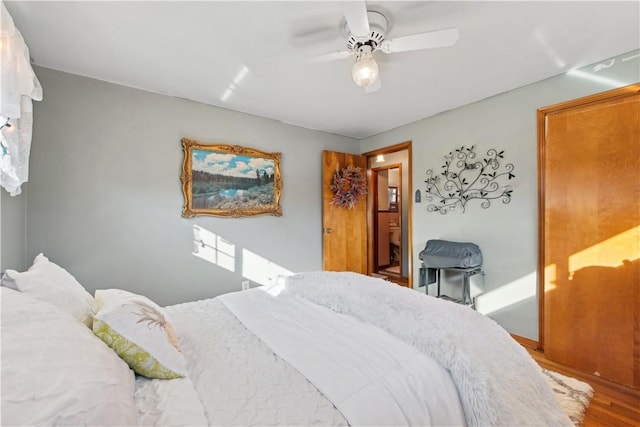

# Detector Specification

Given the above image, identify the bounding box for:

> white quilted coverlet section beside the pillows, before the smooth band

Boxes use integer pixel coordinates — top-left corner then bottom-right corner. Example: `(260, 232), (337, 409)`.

(136, 298), (347, 426)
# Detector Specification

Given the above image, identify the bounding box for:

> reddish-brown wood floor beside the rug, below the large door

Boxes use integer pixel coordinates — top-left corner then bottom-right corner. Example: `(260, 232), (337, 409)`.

(527, 348), (640, 427)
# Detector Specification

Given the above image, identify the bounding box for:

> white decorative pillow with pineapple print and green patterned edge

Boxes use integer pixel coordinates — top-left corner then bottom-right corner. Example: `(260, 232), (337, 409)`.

(93, 289), (186, 379)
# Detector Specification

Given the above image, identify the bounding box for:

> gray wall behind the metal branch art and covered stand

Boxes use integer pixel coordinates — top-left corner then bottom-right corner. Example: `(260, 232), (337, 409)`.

(361, 52), (640, 339)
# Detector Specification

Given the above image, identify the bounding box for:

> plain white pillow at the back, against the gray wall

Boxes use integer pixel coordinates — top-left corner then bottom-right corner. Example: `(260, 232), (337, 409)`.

(2, 254), (94, 327)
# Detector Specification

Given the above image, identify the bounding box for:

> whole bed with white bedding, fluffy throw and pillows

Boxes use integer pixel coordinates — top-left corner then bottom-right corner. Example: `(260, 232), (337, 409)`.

(0, 254), (572, 426)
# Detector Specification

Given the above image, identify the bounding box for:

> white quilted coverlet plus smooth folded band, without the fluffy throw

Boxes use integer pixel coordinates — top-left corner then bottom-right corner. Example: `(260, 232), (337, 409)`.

(136, 285), (465, 426)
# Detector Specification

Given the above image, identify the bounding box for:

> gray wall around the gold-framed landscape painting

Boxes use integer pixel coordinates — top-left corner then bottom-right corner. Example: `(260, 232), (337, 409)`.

(11, 68), (359, 305)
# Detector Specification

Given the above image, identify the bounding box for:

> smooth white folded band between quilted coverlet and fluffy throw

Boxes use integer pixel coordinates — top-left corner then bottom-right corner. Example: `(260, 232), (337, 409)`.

(220, 285), (465, 426)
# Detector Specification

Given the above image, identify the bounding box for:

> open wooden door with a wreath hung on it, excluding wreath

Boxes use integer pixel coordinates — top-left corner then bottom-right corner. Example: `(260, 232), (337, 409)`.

(322, 151), (367, 274)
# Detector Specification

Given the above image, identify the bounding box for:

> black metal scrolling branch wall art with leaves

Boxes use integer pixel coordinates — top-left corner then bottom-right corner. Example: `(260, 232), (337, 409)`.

(425, 145), (515, 215)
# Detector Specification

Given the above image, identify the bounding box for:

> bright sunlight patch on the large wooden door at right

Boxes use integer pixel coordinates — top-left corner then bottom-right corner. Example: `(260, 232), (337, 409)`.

(569, 225), (640, 277)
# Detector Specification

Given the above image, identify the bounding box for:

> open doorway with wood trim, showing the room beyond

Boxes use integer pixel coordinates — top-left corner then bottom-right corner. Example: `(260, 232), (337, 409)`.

(363, 141), (413, 287)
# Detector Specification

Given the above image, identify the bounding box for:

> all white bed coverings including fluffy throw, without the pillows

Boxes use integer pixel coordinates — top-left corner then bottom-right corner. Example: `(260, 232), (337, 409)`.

(136, 273), (571, 426)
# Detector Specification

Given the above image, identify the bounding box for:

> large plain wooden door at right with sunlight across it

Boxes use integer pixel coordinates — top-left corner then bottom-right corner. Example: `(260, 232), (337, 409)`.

(538, 85), (640, 387)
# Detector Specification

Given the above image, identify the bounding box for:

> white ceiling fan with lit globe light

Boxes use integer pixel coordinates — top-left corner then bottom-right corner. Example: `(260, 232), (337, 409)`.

(311, 1), (460, 92)
